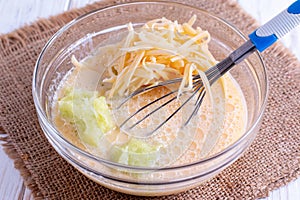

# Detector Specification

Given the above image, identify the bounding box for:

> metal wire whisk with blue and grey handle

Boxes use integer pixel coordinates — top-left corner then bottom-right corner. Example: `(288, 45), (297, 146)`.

(118, 0), (300, 136)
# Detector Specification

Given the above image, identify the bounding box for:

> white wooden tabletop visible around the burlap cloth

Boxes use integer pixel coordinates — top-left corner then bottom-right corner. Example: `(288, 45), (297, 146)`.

(0, 0), (300, 200)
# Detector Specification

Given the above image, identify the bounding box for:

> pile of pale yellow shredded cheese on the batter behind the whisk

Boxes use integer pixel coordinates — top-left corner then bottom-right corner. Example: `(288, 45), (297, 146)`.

(72, 15), (217, 99)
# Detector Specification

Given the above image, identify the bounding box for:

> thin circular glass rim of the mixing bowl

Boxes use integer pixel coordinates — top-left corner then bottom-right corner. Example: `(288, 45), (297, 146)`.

(32, 0), (269, 171)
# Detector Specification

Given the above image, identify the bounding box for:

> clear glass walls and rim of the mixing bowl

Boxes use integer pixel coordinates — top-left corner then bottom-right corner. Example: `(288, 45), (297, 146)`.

(33, 2), (268, 196)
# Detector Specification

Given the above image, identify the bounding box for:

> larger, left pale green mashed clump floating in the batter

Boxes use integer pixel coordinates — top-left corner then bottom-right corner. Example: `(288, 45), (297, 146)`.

(58, 89), (114, 147)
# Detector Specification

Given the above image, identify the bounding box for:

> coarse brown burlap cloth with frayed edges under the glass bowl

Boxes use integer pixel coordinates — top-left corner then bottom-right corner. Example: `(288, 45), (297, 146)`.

(0, 0), (300, 199)
